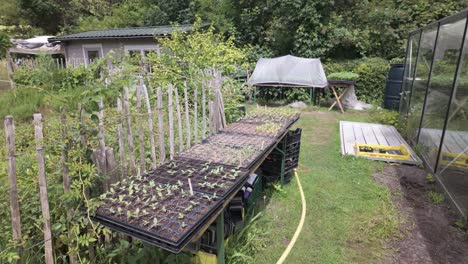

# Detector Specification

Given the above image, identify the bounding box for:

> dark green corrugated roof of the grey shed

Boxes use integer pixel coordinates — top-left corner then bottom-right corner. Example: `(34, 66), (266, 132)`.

(49, 25), (192, 42)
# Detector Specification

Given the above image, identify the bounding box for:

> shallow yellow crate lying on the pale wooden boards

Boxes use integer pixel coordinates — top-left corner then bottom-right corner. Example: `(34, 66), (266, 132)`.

(355, 143), (411, 160)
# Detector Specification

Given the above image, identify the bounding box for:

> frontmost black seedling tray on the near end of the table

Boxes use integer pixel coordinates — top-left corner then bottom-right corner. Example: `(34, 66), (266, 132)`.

(94, 178), (222, 249)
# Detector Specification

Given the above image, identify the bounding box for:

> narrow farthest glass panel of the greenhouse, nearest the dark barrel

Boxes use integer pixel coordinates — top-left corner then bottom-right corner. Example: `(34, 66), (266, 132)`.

(400, 32), (421, 119)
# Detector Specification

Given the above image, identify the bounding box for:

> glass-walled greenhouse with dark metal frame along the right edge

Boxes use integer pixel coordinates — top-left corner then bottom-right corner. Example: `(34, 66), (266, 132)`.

(400, 10), (468, 218)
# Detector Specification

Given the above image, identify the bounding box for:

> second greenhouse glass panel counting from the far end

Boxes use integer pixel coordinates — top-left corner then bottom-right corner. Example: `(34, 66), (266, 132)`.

(407, 24), (437, 142)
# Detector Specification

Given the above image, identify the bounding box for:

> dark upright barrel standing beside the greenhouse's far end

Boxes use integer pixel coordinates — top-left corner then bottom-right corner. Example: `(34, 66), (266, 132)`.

(384, 64), (405, 110)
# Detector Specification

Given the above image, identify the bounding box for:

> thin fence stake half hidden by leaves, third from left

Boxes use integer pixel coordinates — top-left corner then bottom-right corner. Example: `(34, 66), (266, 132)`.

(60, 109), (77, 264)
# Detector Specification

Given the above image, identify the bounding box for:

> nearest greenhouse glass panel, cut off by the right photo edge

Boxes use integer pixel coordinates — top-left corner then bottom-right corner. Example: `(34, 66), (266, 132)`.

(437, 18), (468, 215)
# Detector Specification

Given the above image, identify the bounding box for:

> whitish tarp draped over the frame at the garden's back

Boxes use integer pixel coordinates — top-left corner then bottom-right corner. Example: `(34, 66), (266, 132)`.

(248, 55), (328, 88)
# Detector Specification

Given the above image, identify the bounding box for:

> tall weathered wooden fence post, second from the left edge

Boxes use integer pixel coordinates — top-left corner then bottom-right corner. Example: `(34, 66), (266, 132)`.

(34, 114), (54, 264)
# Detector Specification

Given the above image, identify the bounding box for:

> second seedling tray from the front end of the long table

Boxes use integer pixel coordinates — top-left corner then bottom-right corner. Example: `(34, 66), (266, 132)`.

(142, 157), (248, 197)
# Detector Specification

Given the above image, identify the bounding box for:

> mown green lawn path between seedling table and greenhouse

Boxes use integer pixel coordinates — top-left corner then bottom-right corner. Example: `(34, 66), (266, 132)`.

(253, 108), (398, 263)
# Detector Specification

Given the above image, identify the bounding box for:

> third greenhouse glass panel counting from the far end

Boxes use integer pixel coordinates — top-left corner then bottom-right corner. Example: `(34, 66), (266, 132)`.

(418, 17), (466, 171)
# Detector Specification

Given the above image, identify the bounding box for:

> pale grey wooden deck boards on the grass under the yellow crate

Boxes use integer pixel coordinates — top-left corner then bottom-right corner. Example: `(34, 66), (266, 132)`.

(340, 121), (422, 165)
